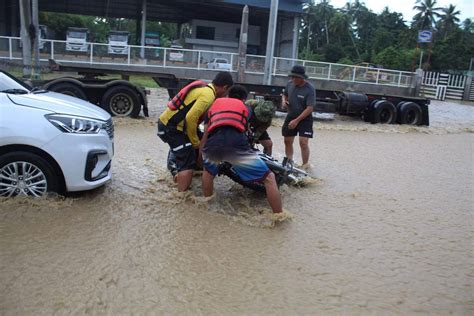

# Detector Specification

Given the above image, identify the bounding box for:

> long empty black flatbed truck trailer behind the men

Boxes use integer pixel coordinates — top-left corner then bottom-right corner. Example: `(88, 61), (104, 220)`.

(31, 61), (430, 126)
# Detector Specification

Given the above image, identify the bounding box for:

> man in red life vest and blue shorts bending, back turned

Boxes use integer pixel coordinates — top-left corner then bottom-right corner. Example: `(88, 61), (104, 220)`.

(201, 85), (282, 213)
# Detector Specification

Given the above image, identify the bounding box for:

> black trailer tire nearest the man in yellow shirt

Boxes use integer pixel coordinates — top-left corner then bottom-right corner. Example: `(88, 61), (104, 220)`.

(100, 85), (141, 117)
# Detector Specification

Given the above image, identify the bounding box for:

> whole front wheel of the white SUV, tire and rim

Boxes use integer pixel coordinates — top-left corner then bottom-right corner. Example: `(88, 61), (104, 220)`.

(0, 151), (60, 197)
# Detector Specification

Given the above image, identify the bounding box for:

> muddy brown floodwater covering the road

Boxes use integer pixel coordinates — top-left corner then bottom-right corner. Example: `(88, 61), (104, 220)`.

(0, 90), (474, 315)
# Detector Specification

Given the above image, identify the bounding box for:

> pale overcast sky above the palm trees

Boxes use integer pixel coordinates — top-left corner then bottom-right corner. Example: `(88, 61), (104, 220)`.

(328, 0), (474, 22)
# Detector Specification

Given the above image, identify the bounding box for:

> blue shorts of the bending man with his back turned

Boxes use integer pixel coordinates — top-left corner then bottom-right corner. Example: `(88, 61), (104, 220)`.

(203, 127), (270, 182)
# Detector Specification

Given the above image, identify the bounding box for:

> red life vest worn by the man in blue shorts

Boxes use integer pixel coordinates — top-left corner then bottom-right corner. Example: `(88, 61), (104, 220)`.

(207, 98), (249, 133)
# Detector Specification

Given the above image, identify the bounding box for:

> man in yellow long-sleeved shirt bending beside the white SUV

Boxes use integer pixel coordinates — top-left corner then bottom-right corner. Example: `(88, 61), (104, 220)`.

(158, 72), (234, 191)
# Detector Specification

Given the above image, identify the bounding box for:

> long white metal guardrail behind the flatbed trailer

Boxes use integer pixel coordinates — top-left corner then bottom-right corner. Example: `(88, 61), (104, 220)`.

(0, 36), (415, 87)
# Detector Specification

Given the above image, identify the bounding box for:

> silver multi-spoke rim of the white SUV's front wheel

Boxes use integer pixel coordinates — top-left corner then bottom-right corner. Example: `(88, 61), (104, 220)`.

(0, 161), (48, 197)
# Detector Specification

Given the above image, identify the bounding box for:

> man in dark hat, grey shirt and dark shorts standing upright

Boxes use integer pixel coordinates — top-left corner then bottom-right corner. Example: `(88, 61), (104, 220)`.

(282, 65), (316, 169)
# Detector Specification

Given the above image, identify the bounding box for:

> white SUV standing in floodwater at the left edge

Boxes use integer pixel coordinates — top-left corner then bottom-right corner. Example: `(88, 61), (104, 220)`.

(0, 71), (114, 197)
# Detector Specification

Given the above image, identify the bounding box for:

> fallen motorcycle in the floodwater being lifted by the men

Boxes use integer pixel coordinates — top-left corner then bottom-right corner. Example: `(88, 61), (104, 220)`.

(167, 146), (308, 192)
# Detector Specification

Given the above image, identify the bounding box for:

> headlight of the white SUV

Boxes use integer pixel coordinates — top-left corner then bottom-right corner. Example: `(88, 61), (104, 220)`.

(45, 114), (105, 134)
